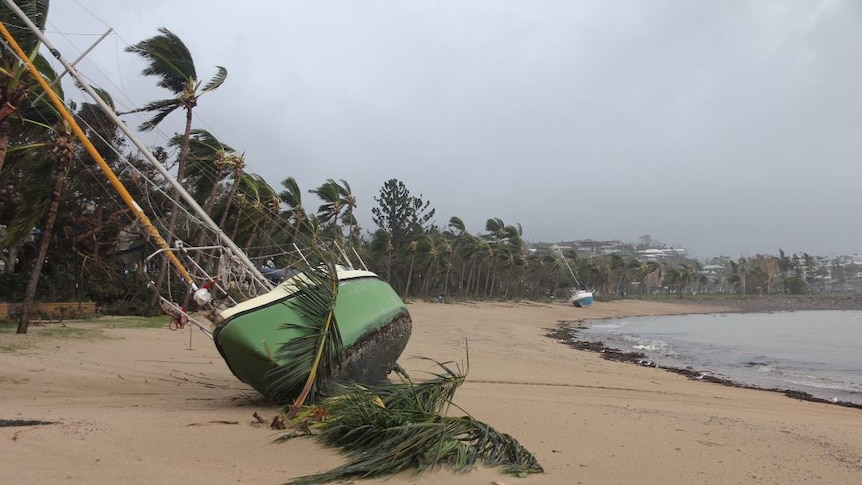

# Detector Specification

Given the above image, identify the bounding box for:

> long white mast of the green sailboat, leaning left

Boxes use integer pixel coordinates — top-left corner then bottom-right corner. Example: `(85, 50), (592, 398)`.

(3, 0), (273, 289)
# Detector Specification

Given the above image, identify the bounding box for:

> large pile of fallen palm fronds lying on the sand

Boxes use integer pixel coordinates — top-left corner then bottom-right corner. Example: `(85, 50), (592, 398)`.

(288, 358), (543, 485)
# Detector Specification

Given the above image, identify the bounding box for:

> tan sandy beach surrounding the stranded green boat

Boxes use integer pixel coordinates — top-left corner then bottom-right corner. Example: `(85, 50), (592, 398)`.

(0, 301), (862, 485)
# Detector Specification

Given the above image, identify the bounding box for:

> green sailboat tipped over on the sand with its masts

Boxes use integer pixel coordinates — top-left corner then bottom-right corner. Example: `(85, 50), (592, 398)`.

(0, 6), (412, 402)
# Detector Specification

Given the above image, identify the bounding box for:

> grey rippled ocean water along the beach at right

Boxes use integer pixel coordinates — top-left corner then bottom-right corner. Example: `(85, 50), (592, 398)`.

(578, 311), (862, 404)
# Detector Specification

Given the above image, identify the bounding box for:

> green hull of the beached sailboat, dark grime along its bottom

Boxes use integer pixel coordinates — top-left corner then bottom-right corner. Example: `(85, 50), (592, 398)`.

(213, 276), (412, 395)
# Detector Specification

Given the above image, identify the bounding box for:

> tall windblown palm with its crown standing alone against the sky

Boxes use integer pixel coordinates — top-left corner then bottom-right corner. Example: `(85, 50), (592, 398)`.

(126, 27), (227, 302)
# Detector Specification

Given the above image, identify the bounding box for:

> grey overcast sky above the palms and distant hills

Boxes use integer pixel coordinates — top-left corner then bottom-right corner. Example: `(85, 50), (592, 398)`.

(38, 0), (862, 258)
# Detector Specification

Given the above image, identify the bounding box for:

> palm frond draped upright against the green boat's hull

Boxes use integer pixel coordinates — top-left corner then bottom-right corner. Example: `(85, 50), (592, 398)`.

(264, 255), (343, 406)
